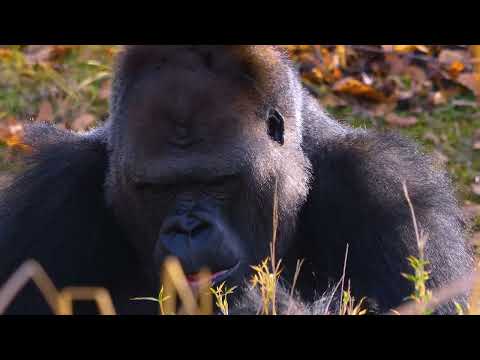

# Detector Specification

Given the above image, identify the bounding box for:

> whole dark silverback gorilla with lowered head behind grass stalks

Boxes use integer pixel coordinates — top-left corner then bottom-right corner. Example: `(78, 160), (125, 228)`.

(0, 45), (473, 314)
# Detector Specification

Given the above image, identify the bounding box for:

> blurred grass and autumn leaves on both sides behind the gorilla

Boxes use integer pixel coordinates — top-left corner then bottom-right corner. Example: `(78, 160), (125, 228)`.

(0, 45), (480, 248)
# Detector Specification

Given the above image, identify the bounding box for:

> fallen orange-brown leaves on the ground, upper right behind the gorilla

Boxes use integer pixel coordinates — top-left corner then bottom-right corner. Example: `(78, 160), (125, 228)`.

(285, 45), (480, 127)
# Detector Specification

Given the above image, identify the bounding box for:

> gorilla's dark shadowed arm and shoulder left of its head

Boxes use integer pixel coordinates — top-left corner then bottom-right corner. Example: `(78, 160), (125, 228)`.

(0, 125), (149, 314)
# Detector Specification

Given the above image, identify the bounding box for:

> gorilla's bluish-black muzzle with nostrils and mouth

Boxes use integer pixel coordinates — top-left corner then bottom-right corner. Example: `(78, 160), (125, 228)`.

(154, 195), (246, 286)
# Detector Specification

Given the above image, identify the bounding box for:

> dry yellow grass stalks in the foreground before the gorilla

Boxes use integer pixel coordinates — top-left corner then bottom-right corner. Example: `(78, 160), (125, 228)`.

(0, 183), (480, 315)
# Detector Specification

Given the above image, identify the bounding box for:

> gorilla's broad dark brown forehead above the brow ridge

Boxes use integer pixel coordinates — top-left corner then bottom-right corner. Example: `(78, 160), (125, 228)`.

(122, 68), (266, 143)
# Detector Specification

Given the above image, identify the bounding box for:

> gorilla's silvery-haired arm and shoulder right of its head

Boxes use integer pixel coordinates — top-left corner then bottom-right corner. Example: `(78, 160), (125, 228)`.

(299, 102), (472, 312)
